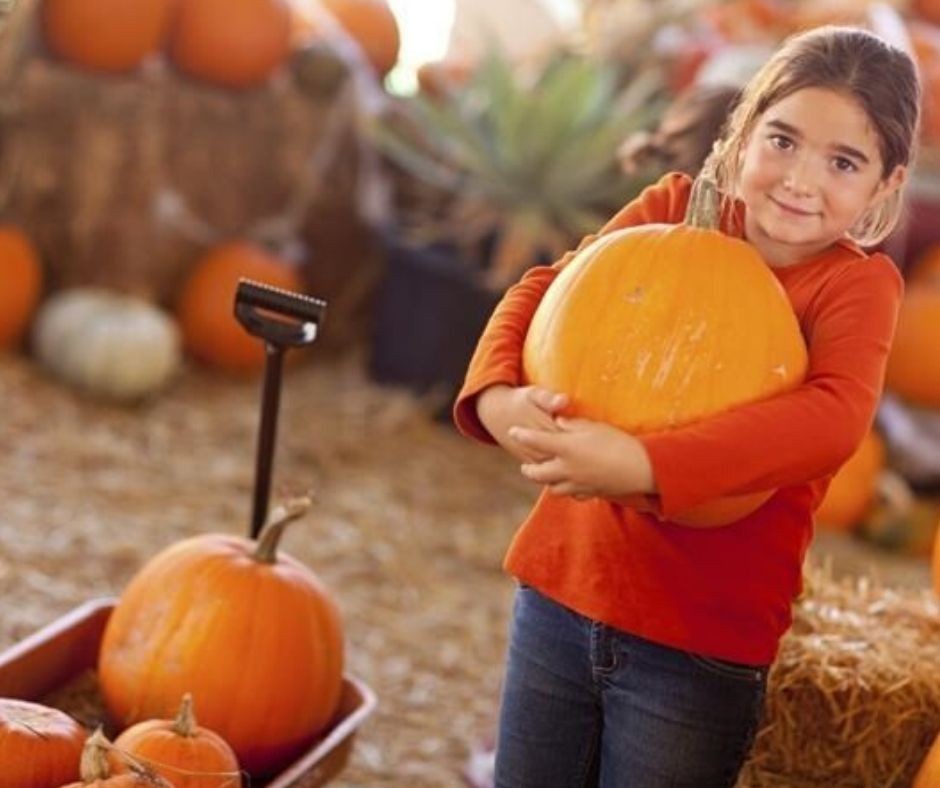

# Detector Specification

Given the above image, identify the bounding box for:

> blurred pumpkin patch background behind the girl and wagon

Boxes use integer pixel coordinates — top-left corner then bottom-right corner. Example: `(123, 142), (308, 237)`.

(0, 0), (940, 786)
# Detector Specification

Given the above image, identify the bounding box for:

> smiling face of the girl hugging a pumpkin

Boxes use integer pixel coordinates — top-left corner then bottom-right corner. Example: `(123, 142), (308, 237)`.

(739, 88), (906, 266)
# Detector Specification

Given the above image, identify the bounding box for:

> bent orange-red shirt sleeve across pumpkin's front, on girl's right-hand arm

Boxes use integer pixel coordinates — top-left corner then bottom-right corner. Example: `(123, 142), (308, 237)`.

(640, 255), (903, 518)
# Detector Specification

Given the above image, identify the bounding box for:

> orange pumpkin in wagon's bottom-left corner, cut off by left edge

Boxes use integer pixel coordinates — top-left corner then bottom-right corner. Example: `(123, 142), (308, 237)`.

(0, 698), (88, 788)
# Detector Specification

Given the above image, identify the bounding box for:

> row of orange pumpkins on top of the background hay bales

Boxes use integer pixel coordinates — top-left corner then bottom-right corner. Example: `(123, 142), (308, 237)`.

(40, 0), (399, 89)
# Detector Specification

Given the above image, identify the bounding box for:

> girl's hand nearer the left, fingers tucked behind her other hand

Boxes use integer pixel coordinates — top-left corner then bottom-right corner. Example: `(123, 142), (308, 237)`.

(477, 384), (568, 462)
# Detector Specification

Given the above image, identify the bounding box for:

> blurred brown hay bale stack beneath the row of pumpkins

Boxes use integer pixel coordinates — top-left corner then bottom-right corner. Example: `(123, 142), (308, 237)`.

(0, 0), (384, 350)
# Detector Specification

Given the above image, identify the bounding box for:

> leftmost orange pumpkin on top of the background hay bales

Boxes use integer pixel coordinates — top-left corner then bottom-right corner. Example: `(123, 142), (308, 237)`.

(41, 0), (174, 73)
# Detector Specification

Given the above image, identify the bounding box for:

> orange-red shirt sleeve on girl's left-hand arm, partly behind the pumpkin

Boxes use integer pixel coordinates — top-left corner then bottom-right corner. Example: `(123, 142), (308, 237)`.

(453, 173), (692, 443)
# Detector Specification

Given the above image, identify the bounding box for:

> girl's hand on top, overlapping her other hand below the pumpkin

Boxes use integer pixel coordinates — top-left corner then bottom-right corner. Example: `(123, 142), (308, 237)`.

(509, 418), (656, 499)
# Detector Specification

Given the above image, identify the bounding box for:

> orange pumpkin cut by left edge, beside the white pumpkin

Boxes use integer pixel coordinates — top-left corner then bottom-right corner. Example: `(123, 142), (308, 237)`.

(0, 226), (42, 348)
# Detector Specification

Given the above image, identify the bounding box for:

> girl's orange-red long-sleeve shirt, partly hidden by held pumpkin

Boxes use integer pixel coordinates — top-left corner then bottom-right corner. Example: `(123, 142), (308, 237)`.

(454, 174), (903, 665)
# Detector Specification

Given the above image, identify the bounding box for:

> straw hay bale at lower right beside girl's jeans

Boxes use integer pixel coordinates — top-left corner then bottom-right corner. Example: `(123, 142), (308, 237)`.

(739, 568), (940, 788)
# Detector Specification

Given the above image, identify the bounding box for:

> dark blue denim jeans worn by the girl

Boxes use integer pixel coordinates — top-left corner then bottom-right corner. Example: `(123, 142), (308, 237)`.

(495, 586), (767, 788)
